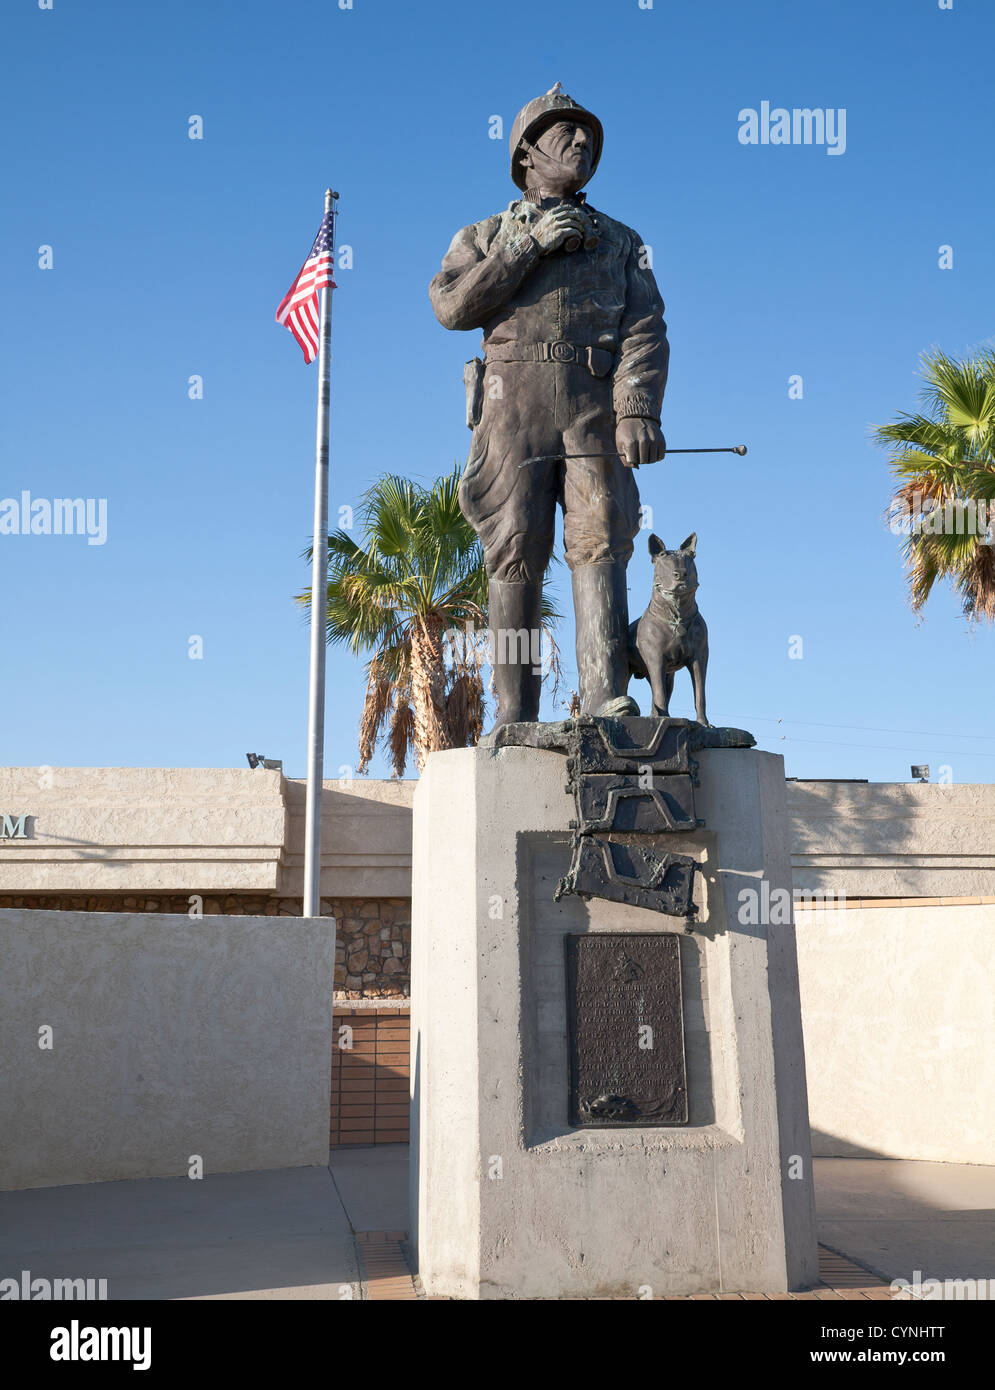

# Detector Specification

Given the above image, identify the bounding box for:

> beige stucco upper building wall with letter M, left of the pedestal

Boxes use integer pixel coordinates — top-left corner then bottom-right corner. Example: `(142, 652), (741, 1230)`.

(0, 767), (416, 898)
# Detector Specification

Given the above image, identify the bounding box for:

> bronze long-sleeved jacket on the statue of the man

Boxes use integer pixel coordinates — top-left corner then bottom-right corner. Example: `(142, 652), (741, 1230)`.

(428, 199), (670, 420)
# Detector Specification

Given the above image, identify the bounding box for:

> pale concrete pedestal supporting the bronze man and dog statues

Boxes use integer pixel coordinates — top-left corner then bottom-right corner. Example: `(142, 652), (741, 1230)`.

(410, 748), (817, 1298)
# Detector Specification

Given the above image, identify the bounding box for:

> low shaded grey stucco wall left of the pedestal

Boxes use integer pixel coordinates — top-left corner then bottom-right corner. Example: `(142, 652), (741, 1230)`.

(0, 909), (334, 1188)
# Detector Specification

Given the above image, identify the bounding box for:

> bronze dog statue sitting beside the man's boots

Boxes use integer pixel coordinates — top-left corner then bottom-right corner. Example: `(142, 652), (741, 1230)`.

(628, 531), (709, 724)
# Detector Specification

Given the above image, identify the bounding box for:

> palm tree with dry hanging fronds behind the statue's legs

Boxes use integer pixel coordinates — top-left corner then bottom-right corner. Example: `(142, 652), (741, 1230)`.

(296, 466), (560, 777)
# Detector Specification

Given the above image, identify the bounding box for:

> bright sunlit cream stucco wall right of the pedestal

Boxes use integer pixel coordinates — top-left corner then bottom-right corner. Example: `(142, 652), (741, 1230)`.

(795, 905), (995, 1163)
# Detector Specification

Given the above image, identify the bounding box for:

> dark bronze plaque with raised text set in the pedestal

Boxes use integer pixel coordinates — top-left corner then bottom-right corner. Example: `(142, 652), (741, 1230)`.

(564, 931), (688, 1129)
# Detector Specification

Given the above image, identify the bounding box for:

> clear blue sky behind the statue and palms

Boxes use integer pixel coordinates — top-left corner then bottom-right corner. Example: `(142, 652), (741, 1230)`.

(0, 0), (995, 783)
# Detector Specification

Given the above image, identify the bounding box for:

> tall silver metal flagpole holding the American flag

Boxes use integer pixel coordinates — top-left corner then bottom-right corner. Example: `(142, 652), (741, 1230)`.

(304, 188), (339, 917)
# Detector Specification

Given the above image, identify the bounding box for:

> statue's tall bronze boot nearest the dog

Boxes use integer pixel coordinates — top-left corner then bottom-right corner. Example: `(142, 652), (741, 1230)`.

(573, 560), (639, 716)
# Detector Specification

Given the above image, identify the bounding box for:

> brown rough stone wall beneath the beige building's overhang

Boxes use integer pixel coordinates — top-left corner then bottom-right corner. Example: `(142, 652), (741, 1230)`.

(0, 888), (411, 999)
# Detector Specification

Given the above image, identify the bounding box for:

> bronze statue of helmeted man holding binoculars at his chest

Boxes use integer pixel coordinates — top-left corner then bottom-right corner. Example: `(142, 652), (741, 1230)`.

(429, 82), (670, 724)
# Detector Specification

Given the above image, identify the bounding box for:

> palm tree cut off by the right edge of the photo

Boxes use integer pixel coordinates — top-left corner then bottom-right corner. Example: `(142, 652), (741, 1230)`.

(874, 348), (995, 621)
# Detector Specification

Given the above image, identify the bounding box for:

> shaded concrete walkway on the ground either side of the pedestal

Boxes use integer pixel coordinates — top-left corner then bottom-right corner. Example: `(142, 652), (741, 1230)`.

(0, 1144), (995, 1300)
